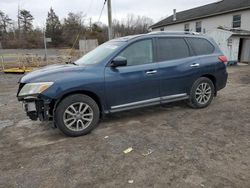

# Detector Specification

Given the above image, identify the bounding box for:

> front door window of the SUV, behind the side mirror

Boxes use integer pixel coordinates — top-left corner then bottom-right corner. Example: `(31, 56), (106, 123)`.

(119, 39), (153, 66)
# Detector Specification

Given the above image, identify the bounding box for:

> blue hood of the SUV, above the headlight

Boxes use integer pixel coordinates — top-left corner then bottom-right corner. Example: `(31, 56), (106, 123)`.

(19, 64), (85, 83)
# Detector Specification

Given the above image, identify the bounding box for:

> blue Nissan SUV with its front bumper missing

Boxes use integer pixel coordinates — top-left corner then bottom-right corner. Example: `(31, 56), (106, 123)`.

(17, 32), (228, 136)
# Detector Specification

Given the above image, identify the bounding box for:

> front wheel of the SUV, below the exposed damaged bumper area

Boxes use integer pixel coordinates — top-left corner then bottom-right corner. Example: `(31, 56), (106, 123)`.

(55, 94), (100, 137)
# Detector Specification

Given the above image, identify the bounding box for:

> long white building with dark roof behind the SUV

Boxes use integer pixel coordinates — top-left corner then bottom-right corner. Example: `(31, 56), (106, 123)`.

(151, 0), (250, 63)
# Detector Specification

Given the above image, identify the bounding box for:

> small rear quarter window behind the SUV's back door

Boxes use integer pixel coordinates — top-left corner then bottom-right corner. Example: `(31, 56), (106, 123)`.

(187, 38), (214, 55)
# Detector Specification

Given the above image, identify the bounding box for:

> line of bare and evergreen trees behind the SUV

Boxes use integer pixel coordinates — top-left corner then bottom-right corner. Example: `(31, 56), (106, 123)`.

(0, 8), (153, 48)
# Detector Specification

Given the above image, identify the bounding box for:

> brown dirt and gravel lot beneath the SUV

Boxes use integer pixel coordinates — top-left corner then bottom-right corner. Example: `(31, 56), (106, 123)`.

(0, 66), (250, 188)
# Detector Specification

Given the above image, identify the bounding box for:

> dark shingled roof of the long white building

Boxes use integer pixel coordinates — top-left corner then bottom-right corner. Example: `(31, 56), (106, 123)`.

(150, 0), (250, 29)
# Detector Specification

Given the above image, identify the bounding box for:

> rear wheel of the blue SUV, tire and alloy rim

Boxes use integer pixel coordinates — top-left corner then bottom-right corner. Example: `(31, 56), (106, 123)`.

(187, 77), (215, 109)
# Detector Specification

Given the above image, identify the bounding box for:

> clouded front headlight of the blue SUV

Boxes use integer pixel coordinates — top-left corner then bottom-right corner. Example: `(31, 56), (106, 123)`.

(18, 82), (53, 96)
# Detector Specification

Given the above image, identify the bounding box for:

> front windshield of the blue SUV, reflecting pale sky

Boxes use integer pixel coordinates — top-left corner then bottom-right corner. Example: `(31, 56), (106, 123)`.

(75, 42), (124, 65)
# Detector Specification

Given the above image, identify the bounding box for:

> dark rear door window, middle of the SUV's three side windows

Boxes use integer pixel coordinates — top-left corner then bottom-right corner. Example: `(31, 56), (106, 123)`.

(158, 38), (189, 61)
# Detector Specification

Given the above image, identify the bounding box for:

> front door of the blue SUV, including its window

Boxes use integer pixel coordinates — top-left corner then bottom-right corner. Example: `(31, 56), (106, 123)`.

(105, 39), (160, 112)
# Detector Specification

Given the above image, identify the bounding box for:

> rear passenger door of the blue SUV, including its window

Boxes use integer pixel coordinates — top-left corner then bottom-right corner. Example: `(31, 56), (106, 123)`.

(157, 37), (199, 101)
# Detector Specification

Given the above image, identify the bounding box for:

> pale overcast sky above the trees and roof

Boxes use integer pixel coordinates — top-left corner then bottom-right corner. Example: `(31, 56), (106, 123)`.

(0, 0), (217, 27)
